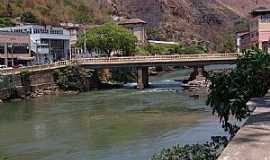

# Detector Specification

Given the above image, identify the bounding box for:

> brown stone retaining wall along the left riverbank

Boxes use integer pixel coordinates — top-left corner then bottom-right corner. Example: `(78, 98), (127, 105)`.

(0, 70), (100, 100)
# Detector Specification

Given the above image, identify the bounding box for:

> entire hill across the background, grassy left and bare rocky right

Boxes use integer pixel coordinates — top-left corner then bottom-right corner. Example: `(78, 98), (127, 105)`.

(0, 0), (270, 48)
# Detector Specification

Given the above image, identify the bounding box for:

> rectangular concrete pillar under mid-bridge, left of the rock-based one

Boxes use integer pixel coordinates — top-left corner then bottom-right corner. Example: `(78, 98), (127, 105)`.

(137, 67), (149, 89)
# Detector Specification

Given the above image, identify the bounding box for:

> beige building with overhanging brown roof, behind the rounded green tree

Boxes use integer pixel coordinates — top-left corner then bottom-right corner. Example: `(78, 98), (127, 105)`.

(118, 18), (147, 44)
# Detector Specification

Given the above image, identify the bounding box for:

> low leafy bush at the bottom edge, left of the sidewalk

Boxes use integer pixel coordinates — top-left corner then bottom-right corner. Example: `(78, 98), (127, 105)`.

(151, 137), (228, 160)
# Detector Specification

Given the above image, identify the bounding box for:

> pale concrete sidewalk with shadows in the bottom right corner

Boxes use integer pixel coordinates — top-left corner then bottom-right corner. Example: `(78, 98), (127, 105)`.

(218, 94), (270, 160)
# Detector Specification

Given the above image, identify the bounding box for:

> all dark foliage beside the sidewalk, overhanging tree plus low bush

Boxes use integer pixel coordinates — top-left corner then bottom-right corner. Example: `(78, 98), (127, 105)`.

(152, 49), (270, 160)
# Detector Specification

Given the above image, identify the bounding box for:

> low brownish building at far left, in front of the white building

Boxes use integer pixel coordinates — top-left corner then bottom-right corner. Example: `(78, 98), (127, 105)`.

(0, 31), (33, 66)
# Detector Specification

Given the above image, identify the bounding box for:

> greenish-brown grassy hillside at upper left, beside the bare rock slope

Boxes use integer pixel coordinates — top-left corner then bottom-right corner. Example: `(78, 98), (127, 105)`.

(0, 0), (111, 24)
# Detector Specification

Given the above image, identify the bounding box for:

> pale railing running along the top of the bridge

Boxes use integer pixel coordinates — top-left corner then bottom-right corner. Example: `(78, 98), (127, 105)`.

(0, 53), (239, 75)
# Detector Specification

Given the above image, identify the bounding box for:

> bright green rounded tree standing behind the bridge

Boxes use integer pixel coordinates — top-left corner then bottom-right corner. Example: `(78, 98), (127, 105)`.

(79, 23), (137, 57)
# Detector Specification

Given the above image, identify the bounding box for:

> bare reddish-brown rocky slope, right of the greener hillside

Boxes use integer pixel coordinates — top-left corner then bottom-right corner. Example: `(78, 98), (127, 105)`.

(113, 0), (270, 48)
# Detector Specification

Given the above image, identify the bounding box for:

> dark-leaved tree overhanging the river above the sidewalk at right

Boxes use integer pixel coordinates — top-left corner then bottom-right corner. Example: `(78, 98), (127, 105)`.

(207, 50), (270, 133)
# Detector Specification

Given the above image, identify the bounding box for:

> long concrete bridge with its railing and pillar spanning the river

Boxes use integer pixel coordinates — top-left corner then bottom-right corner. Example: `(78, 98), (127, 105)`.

(0, 53), (239, 89)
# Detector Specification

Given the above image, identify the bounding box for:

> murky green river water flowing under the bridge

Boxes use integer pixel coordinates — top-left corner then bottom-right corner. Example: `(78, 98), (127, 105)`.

(0, 65), (230, 160)
